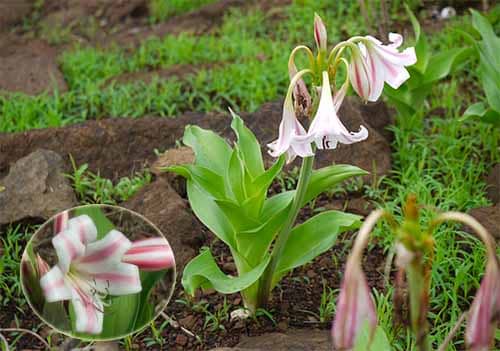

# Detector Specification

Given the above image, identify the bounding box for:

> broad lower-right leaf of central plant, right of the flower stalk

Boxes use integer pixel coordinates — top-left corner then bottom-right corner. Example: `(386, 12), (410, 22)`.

(273, 211), (361, 283)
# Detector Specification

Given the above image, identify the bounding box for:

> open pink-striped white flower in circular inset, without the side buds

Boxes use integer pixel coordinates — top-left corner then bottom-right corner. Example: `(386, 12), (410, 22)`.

(40, 215), (142, 334)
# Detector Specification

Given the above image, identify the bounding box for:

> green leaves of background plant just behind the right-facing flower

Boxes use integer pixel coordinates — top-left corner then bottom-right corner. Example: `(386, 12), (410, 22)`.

(384, 7), (473, 117)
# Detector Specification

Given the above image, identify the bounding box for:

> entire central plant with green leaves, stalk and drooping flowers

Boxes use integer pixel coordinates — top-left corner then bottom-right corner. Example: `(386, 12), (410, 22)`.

(167, 15), (416, 313)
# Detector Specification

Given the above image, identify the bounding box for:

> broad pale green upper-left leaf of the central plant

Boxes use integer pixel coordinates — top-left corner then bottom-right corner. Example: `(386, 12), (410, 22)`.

(182, 125), (231, 175)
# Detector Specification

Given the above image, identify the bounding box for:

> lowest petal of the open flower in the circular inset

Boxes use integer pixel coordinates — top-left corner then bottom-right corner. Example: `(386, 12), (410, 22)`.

(71, 289), (104, 335)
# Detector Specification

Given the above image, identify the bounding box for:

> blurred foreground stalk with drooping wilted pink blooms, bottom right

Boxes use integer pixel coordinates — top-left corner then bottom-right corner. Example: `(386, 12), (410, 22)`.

(332, 195), (500, 351)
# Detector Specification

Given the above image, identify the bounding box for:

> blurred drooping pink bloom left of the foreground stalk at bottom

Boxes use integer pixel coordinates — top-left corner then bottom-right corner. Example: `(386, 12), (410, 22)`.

(332, 257), (377, 351)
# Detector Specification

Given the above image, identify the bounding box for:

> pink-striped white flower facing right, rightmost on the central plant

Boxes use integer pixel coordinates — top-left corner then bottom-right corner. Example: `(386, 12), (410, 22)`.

(349, 33), (417, 101)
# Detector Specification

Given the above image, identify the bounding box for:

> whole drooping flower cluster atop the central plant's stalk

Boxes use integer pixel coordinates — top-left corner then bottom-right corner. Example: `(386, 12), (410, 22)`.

(268, 15), (416, 162)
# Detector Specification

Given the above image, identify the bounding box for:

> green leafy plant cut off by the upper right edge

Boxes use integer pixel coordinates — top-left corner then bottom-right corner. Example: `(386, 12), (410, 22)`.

(464, 10), (500, 127)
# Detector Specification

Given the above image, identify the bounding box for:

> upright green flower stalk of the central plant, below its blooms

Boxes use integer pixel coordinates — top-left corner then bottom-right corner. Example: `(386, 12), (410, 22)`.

(257, 156), (314, 307)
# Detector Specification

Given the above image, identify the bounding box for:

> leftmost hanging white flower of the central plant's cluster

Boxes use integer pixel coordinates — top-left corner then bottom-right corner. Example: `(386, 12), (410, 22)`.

(267, 91), (313, 163)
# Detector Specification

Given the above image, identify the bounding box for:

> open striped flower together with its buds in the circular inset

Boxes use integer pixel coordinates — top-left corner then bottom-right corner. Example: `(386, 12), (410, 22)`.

(37, 212), (175, 334)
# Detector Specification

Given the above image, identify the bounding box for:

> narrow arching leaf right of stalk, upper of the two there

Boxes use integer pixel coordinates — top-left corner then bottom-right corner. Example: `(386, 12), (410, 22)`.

(301, 165), (368, 206)
